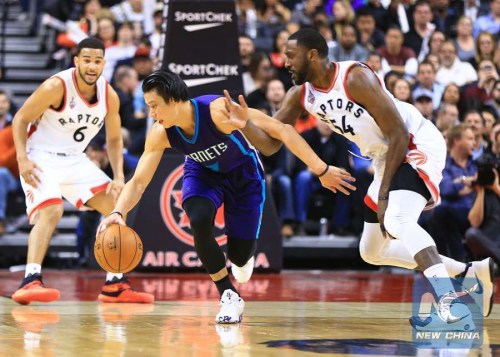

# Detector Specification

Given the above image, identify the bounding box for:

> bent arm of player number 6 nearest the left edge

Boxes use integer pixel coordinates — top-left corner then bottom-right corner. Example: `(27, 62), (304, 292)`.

(12, 78), (65, 188)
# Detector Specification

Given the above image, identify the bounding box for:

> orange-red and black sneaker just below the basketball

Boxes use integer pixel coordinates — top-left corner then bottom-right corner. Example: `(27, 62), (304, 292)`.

(97, 277), (155, 304)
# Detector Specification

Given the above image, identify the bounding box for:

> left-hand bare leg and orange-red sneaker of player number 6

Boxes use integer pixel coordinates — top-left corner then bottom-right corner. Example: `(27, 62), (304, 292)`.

(12, 204), (63, 305)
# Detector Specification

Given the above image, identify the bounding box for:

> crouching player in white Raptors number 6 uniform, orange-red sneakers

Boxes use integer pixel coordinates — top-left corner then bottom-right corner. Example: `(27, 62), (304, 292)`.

(12, 38), (154, 305)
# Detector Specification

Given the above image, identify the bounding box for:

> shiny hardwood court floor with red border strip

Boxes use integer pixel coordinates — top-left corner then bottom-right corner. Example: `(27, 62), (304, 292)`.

(0, 271), (500, 357)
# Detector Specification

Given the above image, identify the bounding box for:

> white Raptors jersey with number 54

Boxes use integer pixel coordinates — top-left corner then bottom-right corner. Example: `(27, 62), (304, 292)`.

(302, 61), (426, 158)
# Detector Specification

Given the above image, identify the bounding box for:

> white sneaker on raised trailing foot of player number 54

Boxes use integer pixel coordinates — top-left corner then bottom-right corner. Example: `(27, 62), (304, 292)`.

(465, 258), (495, 317)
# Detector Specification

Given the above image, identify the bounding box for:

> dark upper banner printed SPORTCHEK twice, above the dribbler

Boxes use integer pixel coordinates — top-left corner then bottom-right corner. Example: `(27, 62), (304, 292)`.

(162, 0), (243, 97)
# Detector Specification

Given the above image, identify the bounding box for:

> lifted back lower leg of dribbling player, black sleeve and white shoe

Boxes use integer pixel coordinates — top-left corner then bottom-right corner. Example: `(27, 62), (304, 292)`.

(227, 237), (257, 284)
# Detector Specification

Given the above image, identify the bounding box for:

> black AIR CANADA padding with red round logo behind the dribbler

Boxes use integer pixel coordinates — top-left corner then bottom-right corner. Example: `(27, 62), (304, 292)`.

(127, 152), (283, 271)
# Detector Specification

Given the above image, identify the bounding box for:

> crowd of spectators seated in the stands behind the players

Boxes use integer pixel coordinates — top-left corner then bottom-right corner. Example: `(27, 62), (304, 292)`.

(0, 0), (500, 263)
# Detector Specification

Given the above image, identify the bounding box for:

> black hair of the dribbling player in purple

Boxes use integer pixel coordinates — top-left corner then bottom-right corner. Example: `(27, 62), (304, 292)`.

(142, 69), (189, 103)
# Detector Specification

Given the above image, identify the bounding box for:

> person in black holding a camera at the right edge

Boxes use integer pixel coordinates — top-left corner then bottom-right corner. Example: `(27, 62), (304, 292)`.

(465, 149), (500, 264)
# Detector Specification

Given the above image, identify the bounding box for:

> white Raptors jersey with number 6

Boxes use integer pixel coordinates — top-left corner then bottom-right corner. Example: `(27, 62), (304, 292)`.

(26, 68), (108, 155)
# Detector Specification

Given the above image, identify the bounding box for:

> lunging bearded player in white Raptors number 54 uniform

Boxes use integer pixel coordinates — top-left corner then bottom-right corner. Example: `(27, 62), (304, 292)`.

(226, 29), (494, 330)
